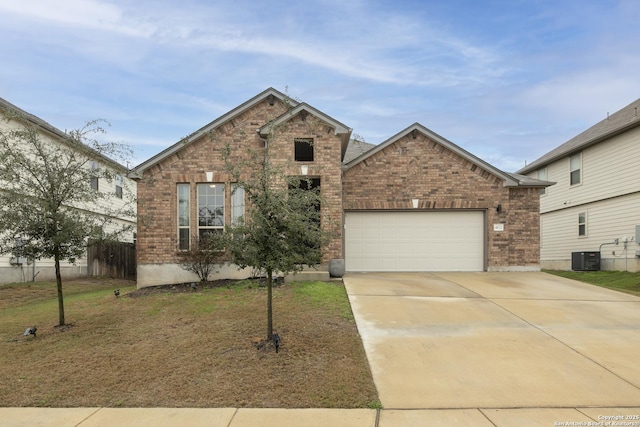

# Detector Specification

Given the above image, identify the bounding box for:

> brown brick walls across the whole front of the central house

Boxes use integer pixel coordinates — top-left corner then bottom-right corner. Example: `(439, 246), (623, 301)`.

(138, 100), (540, 276)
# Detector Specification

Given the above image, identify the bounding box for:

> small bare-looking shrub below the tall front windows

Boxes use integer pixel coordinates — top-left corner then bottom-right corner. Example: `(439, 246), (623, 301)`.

(179, 232), (227, 282)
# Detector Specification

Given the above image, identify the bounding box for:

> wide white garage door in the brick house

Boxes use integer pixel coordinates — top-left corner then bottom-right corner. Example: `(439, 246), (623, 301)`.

(345, 211), (485, 271)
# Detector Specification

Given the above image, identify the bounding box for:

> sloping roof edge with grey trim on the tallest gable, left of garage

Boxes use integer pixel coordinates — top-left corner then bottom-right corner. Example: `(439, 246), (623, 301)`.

(129, 87), (298, 178)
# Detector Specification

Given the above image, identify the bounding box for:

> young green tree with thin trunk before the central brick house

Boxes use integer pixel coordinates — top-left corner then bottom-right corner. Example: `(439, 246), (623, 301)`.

(224, 130), (329, 340)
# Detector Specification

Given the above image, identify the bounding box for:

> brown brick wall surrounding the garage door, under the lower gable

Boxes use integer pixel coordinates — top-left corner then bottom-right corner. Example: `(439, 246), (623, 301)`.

(343, 133), (539, 269)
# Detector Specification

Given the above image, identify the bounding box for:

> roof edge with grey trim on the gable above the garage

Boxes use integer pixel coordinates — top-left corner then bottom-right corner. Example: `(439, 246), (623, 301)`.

(344, 123), (554, 187)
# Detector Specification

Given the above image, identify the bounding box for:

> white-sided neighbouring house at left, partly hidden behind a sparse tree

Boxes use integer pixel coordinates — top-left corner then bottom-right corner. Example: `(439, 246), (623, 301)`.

(0, 98), (136, 283)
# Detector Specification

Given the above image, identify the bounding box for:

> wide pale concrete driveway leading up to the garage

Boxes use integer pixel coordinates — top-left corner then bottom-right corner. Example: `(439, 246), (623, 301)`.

(344, 272), (640, 426)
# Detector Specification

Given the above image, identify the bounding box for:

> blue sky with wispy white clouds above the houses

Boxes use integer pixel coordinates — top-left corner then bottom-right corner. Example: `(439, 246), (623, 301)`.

(0, 0), (640, 172)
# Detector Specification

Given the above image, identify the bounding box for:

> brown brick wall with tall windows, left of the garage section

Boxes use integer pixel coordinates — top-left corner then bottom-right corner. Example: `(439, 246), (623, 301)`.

(138, 100), (342, 265)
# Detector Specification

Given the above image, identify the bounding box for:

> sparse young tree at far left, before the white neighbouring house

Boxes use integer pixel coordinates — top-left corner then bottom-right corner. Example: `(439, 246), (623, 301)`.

(0, 107), (135, 326)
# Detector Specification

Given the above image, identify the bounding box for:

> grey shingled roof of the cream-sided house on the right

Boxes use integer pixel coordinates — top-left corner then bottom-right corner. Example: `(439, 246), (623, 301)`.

(518, 99), (640, 174)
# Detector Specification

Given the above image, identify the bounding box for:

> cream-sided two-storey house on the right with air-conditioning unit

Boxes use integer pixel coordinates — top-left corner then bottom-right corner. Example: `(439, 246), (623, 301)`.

(518, 99), (640, 271)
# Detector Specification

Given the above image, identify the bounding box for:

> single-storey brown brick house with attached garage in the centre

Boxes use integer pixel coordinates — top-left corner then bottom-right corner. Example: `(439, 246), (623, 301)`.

(130, 88), (550, 287)
